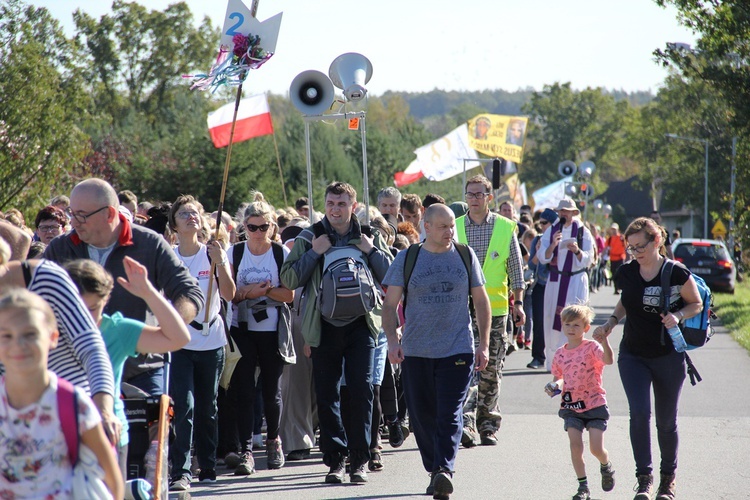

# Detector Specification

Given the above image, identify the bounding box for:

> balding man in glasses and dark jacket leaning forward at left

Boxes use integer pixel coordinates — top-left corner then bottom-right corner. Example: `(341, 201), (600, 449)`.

(44, 179), (204, 395)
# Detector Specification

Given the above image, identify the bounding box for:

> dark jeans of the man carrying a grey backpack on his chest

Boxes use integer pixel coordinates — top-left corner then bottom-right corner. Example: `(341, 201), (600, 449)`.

(312, 317), (375, 470)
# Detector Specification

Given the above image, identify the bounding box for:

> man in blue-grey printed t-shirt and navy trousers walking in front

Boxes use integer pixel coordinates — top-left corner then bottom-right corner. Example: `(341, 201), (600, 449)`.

(383, 204), (491, 499)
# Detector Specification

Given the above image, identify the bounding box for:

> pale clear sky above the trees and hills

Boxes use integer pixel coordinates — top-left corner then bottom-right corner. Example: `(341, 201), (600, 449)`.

(32, 0), (695, 95)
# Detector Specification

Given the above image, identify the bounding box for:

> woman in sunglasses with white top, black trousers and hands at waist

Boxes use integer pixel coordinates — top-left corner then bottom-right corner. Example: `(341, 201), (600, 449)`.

(229, 193), (294, 476)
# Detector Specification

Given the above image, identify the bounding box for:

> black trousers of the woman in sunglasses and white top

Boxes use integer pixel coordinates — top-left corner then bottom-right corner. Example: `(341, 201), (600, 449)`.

(229, 326), (284, 452)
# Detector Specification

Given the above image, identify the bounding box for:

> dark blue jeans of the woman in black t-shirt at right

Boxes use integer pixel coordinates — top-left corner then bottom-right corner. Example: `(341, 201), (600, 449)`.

(617, 349), (685, 475)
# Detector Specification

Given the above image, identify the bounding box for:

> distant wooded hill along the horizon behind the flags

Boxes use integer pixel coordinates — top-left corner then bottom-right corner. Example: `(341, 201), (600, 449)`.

(383, 88), (654, 120)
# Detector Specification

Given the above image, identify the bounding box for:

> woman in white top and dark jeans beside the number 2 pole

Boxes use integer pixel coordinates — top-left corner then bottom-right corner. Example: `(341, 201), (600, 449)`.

(168, 195), (235, 491)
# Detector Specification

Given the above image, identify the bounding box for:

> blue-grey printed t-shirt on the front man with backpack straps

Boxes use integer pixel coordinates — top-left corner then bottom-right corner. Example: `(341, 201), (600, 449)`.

(383, 247), (485, 359)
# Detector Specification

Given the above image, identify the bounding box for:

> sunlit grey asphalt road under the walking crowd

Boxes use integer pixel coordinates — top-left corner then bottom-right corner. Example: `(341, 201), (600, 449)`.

(170, 288), (750, 500)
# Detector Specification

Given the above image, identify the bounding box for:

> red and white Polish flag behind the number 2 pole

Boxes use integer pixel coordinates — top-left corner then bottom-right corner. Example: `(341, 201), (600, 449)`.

(207, 94), (273, 148)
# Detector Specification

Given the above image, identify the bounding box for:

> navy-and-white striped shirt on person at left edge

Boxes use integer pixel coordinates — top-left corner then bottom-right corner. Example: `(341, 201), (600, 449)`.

(0, 260), (114, 397)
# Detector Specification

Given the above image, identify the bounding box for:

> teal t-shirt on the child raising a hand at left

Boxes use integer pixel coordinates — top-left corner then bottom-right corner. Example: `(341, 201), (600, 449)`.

(99, 312), (145, 447)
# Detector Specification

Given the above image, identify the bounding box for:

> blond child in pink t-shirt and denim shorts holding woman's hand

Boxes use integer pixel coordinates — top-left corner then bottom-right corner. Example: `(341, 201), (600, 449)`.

(544, 305), (615, 500)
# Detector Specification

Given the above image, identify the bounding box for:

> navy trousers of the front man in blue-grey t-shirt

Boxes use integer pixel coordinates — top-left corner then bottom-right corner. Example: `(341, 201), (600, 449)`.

(401, 353), (474, 472)
